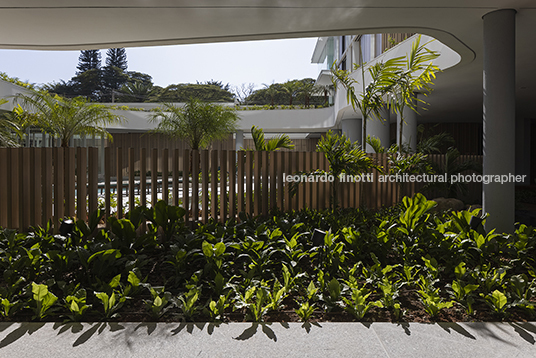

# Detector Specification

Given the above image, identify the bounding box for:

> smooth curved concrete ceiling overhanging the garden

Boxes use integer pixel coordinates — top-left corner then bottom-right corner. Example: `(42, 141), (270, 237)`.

(0, 0), (536, 121)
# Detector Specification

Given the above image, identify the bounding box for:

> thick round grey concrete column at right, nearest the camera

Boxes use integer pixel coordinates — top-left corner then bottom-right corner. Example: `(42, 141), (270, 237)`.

(482, 9), (516, 233)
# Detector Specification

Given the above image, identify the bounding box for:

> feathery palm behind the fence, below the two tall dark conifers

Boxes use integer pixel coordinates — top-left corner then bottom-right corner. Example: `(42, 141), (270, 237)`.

(15, 91), (121, 147)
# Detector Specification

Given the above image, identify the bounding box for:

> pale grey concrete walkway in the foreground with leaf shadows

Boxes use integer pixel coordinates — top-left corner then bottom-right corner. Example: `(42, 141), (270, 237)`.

(0, 322), (536, 358)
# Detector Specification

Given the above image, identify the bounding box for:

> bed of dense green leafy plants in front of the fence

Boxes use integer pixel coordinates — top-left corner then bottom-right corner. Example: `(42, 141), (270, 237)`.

(0, 194), (536, 322)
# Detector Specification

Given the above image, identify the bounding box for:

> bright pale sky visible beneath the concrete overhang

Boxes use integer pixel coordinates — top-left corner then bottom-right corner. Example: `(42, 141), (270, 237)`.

(0, 38), (319, 88)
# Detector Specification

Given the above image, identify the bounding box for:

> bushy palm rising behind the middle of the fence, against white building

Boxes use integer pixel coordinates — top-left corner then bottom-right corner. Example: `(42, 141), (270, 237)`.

(151, 98), (238, 150)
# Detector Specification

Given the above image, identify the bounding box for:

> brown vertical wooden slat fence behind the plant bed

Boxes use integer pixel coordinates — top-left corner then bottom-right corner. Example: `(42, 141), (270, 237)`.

(0, 148), (482, 230)
